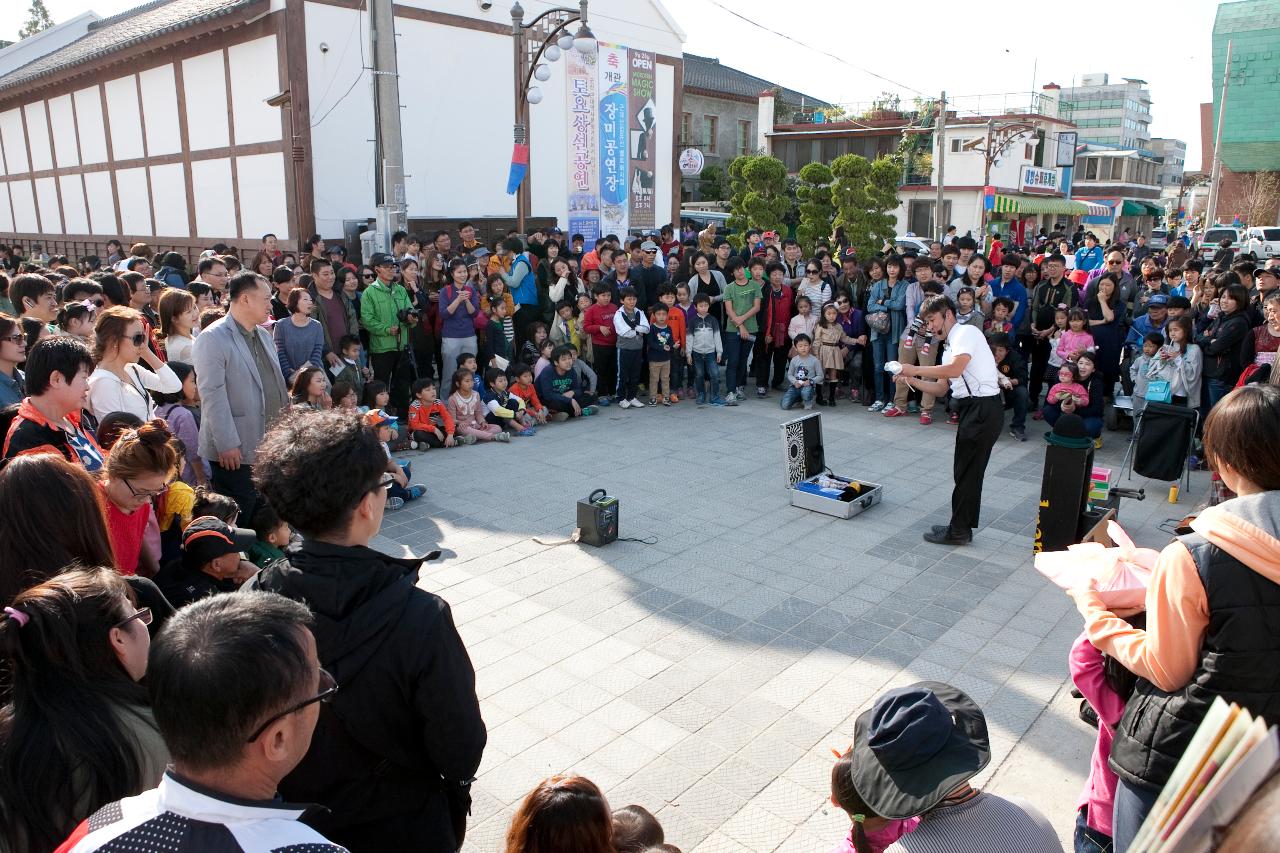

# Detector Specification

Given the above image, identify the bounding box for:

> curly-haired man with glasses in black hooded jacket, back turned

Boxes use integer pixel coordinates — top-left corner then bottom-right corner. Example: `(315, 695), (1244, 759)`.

(250, 411), (488, 853)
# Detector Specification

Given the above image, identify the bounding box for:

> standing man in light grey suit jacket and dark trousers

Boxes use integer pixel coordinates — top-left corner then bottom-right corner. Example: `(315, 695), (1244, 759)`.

(192, 272), (289, 514)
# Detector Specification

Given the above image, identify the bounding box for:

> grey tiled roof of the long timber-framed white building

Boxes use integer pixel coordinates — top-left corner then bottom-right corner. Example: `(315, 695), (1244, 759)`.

(0, 0), (253, 91)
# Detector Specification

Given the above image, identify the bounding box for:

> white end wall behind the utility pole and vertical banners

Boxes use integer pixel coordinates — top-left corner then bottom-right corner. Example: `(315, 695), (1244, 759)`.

(305, 0), (684, 234)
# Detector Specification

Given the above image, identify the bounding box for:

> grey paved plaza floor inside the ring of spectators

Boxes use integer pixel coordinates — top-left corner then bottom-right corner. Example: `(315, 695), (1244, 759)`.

(375, 394), (1207, 853)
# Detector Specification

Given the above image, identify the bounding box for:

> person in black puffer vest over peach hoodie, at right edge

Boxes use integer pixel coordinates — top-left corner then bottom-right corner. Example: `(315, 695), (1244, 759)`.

(1071, 384), (1280, 853)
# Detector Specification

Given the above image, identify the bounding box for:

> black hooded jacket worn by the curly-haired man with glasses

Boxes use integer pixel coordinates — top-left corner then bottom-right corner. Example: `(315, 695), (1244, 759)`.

(250, 540), (488, 853)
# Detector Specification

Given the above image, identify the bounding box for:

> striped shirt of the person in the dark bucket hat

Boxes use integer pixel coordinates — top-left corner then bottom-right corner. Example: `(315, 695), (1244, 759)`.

(884, 793), (1062, 853)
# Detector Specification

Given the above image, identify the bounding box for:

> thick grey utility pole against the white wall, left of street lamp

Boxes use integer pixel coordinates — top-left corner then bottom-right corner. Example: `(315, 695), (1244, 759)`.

(369, 0), (408, 251)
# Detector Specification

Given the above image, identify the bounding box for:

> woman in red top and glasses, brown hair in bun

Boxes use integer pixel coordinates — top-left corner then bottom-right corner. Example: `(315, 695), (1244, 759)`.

(99, 418), (180, 578)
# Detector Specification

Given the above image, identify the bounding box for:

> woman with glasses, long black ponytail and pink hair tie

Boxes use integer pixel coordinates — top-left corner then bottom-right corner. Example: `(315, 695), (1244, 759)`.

(0, 567), (169, 850)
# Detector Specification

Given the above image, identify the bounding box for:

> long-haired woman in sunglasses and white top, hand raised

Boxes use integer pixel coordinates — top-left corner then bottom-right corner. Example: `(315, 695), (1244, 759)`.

(88, 306), (182, 420)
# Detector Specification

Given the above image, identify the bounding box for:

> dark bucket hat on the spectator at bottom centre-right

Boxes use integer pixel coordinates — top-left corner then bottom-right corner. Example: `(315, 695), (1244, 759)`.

(852, 681), (991, 820)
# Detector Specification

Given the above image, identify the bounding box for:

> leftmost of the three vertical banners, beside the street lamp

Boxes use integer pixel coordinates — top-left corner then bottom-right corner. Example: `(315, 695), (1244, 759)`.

(564, 50), (600, 242)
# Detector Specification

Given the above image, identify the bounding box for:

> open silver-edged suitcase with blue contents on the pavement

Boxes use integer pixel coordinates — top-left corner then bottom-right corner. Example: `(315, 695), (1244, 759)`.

(782, 412), (884, 519)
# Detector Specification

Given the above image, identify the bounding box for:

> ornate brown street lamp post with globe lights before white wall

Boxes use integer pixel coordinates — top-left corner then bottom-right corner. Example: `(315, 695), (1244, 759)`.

(511, 0), (596, 234)
